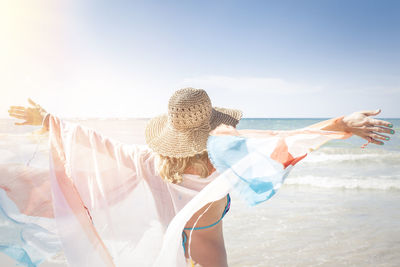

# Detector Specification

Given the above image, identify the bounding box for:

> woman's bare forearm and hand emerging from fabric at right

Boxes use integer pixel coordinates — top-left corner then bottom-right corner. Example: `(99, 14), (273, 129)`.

(308, 109), (394, 145)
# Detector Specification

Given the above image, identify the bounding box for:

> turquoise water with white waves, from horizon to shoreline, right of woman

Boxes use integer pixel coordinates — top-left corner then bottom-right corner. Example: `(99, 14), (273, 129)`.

(238, 118), (400, 190)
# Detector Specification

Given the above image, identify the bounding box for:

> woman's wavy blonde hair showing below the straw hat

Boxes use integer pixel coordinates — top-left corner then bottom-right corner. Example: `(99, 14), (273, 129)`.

(158, 151), (210, 184)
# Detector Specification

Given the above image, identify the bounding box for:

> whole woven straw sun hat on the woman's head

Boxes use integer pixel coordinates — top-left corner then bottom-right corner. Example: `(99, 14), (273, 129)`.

(146, 88), (242, 158)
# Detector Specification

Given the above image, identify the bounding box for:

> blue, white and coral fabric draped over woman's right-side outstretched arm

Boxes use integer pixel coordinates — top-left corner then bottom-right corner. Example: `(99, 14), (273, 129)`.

(207, 122), (351, 206)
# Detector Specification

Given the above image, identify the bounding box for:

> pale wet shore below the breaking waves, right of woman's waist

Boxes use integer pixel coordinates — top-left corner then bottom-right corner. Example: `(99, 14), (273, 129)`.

(224, 185), (400, 267)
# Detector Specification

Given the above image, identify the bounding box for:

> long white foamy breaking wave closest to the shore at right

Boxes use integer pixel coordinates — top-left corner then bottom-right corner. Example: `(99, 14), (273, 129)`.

(285, 175), (400, 190)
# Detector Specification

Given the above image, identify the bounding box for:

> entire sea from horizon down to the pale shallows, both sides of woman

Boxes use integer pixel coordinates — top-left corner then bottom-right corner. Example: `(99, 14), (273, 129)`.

(0, 118), (400, 267)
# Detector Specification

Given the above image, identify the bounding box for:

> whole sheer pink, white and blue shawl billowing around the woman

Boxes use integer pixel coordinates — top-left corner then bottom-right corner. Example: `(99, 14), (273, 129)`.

(0, 115), (351, 267)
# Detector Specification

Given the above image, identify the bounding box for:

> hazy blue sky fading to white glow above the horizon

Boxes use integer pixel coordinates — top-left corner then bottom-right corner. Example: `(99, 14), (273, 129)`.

(0, 0), (400, 117)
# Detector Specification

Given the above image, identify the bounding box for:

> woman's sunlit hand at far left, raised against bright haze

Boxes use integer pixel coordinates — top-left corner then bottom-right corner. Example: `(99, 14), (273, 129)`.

(8, 98), (47, 125)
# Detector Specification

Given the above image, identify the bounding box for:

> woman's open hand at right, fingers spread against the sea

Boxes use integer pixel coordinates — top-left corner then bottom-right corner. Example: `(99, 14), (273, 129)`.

(343, 109), (394, 146)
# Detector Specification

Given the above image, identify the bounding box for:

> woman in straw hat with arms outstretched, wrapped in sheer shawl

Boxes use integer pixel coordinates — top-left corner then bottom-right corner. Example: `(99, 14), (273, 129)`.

(9, 88), (394, 266)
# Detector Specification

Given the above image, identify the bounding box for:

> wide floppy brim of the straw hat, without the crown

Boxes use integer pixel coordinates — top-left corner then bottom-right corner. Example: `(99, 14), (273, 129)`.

(145, 107), (242, 158)
